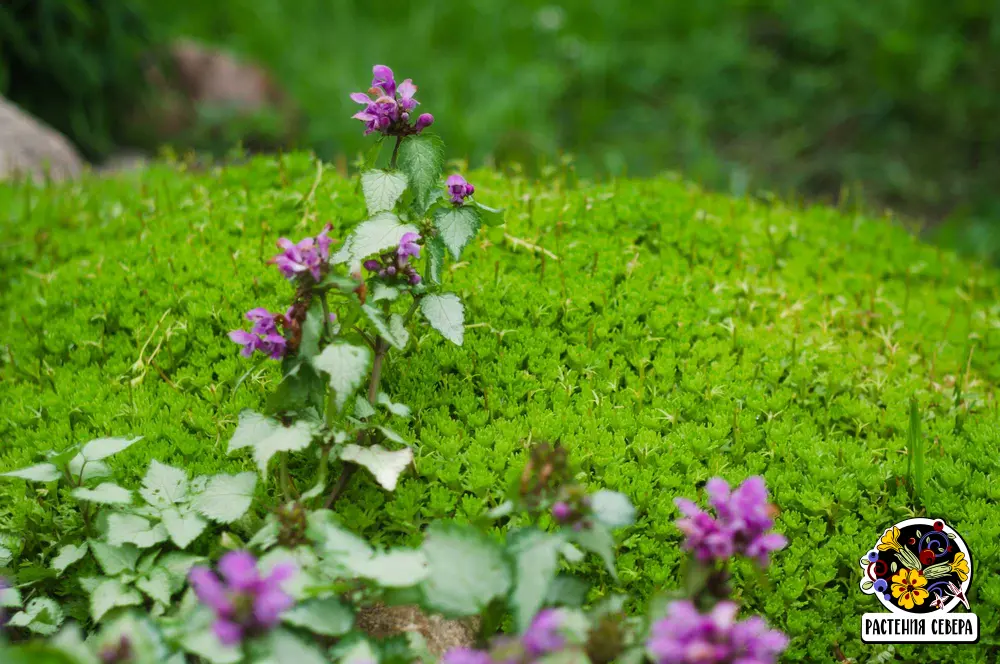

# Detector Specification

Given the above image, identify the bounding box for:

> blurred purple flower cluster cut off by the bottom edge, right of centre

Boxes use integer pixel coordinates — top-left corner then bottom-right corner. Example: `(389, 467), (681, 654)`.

(646, 600), (788, 664)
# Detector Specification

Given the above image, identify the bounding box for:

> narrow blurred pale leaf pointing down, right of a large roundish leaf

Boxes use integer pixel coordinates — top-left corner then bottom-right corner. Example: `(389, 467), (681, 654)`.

(508, 529), (563, 632)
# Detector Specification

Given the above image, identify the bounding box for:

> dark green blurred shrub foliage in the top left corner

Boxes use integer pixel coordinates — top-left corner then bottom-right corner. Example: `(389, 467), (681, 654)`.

(0, 0), (154, 159)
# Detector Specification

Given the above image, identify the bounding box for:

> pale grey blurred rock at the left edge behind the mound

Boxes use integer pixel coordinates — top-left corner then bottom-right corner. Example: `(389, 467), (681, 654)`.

(0, 97), (83, 180)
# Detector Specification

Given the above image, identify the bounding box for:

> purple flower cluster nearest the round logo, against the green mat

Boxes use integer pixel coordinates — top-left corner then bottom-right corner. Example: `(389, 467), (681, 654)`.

(674, 476), (788, 566)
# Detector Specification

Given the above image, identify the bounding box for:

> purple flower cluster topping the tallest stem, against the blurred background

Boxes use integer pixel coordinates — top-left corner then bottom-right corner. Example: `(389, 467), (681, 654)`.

(351, 65), (434, 136)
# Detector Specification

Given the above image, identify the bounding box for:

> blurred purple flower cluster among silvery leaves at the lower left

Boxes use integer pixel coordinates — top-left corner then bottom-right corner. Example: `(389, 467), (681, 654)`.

(188, 551), (295, 646)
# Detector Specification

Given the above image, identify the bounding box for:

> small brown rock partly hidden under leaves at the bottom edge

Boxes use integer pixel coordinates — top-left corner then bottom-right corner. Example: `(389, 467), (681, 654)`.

(357, 604), (478, 656)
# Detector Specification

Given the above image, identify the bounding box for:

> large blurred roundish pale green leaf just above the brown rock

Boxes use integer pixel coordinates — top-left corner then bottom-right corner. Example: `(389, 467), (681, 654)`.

(422, 522), (511, 618)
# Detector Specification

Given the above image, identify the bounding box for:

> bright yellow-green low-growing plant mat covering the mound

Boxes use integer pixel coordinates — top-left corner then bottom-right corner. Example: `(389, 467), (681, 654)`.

(0, 155), (1000, 662)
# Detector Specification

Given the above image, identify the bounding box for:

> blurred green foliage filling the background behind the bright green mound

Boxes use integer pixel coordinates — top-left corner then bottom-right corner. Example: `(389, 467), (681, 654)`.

(0, 0), (1000, 255)
